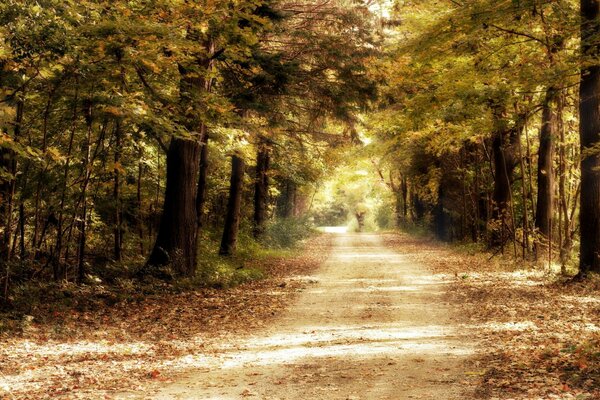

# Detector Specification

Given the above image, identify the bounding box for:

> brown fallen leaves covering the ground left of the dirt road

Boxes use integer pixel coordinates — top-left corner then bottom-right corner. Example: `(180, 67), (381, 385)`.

(0, 238), (331, 400)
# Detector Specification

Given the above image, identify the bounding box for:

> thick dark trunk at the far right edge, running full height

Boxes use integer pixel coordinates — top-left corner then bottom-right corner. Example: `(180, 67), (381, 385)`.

(579, 0), (600, 276)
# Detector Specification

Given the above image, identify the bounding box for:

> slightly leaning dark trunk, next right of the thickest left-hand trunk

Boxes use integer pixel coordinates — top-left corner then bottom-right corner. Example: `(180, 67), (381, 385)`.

(219, 155), (244, 256)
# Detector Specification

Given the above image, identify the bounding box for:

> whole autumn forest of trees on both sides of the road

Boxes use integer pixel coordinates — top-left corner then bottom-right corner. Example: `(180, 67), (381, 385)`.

(0, 0), (600, 299)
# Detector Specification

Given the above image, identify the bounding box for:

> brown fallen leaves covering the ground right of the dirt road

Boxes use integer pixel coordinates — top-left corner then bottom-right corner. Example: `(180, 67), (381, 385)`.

(386, 234), (600, 399)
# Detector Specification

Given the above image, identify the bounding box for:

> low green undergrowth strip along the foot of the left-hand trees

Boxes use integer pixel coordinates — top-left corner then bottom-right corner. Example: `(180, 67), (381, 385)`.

(0, 219), (315, 333)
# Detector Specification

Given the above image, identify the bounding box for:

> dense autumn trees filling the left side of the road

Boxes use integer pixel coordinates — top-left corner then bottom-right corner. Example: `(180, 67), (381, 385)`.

(0, 0), (376, 298)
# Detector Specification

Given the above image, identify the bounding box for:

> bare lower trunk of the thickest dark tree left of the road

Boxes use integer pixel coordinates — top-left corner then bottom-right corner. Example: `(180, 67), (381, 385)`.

(147, 137), (200, 276)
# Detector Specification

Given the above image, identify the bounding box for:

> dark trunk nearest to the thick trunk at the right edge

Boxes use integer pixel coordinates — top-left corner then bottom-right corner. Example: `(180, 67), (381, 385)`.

(535, 87), (558, 257)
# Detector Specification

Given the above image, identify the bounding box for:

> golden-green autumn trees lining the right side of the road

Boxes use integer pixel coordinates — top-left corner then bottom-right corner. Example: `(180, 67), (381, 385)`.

(370, 0), (600, 275)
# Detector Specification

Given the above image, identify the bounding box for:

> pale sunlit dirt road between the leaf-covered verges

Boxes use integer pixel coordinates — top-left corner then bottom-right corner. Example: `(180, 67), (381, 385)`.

(144, 234), (473, 400)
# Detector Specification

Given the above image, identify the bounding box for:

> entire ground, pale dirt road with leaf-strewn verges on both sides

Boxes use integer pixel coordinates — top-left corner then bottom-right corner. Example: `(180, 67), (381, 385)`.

(0, 233), (600, 400)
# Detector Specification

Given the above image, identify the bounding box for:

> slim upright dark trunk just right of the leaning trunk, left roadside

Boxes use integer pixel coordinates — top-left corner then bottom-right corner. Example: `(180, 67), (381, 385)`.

(253, 141), (271, 238)
